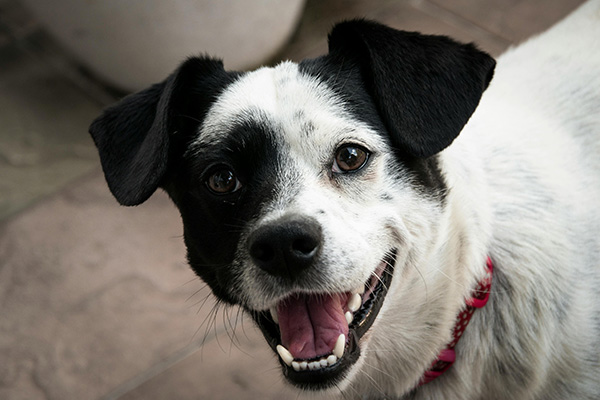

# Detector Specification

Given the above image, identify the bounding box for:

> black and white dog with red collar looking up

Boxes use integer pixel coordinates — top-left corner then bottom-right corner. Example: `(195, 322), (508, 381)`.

(90, 0), (600, 399)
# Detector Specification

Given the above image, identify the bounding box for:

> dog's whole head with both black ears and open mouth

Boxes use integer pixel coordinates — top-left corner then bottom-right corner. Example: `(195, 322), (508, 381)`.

(91, 21), (494, 389)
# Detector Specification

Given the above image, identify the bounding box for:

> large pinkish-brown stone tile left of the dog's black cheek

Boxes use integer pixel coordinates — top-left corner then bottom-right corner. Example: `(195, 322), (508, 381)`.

(0, 170), (214, 399)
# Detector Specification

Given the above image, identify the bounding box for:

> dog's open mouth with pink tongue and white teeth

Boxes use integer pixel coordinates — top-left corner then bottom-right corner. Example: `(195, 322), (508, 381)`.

(253, 251), (396, 390)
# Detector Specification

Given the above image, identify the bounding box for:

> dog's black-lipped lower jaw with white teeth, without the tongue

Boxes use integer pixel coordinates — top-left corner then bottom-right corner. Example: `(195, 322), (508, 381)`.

(251, 250), (396, 391)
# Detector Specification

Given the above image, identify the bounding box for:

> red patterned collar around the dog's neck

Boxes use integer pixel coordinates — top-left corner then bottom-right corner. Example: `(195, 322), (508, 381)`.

(418, 257), (494, 386)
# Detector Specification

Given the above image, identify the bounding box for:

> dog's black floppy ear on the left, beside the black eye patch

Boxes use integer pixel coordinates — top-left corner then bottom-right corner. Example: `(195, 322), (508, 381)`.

(89, 57), (226, 206)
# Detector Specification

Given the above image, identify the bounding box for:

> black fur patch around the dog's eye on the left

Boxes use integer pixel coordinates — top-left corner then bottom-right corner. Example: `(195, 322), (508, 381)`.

(169, 111), (284, 303)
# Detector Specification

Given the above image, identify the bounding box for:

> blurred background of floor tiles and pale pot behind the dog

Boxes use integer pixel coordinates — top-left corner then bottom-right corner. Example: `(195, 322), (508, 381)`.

(0, 0), (582, 400)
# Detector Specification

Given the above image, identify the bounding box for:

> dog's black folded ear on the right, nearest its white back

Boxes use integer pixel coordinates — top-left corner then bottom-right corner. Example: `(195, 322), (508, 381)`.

(329, 20), (495, 158)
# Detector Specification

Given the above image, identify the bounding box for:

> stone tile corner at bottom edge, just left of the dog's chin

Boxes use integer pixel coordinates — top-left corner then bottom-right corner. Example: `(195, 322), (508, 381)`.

(118, 324), (300, 400)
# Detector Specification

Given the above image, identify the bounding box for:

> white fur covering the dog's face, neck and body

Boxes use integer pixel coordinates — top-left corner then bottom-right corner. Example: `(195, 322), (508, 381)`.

(195, 0), (600, 399)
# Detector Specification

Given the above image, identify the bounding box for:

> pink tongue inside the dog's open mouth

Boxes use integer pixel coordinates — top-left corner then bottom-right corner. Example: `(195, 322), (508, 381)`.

(277, 293), (348, 359)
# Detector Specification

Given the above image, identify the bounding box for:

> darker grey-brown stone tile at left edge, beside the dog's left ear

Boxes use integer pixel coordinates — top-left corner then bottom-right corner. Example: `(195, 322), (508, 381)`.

(0, 45), (101, 220)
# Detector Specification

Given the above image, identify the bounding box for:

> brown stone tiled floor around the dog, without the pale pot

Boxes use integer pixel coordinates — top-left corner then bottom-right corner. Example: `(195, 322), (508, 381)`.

(0, 0), (581, 399)
